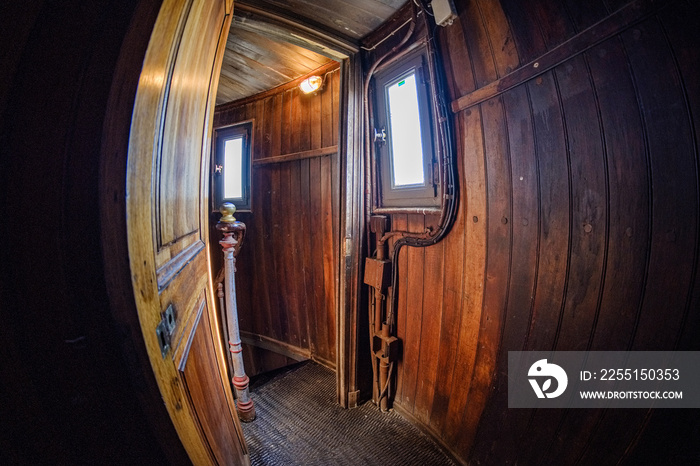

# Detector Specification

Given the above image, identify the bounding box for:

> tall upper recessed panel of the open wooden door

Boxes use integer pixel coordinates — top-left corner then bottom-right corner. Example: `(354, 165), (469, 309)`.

(153, 1), (225, 268)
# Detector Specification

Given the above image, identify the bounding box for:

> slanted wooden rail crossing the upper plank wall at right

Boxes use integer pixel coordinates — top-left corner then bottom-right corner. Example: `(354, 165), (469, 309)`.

(452, 0), (673, 113)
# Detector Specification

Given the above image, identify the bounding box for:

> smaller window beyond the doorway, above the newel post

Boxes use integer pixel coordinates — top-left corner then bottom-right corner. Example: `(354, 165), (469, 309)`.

(214, 122), (253, 211)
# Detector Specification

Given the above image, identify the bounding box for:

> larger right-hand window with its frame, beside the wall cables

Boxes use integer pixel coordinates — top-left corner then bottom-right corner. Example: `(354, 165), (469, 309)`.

(374, 48), (440, 207)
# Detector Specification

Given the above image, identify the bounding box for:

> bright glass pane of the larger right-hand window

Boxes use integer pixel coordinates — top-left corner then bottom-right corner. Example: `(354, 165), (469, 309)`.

(388, 73), (425, 186)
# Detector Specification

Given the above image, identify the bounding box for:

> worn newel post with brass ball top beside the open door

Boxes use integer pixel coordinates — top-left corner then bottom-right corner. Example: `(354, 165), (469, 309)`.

(216, 202), (255, 422)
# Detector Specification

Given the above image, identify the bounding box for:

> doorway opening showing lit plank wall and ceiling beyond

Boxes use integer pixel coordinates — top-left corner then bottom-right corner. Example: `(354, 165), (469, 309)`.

(209, 4), (357, 416)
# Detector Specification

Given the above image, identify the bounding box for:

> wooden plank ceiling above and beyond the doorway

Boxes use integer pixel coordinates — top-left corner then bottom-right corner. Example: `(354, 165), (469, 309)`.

(216, 0), (408, 105)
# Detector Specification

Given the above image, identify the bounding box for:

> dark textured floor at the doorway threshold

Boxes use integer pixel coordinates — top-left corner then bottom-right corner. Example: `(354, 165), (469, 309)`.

(243, 361), (455, 466)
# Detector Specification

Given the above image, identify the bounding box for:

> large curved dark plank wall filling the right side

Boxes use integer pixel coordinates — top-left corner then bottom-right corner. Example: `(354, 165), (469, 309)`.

(366, 0), (700, 464)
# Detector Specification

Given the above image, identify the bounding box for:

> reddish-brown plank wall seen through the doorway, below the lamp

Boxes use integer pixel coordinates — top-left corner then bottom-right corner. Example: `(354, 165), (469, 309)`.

(212, 63), (340, 374)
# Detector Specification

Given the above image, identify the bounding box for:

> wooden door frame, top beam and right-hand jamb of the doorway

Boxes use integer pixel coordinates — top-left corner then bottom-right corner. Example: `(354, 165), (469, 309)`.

(208, 2), (372, 408)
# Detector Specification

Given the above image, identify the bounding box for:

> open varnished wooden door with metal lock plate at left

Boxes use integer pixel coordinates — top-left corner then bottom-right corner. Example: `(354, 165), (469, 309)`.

(127, 0), (249, 465)
